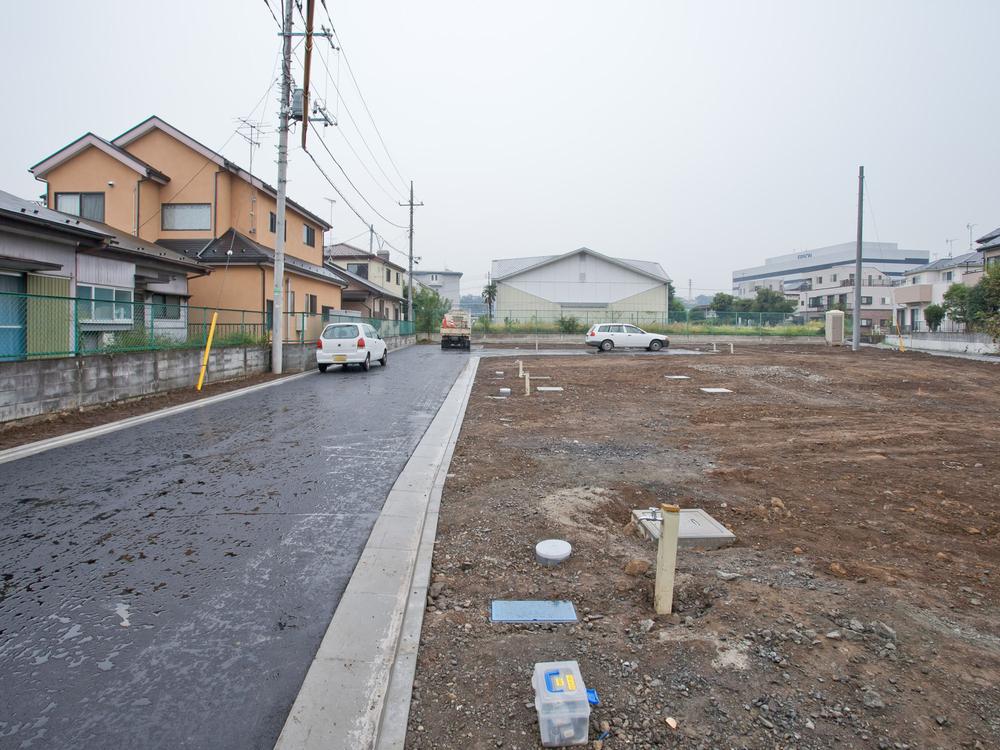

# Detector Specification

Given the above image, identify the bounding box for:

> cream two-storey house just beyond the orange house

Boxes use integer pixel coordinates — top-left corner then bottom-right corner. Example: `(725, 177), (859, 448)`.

(324, 242), (406, 320)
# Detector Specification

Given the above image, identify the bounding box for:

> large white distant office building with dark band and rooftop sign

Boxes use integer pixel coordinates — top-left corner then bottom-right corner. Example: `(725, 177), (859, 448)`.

(733, 242), (930, 328)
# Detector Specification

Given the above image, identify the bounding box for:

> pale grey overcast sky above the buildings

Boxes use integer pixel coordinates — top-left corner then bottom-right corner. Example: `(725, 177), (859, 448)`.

(0, 0), (1000, 295)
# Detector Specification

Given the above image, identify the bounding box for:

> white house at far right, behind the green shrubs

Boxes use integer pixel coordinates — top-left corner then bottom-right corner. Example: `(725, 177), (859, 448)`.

(892, 252), (983, 331)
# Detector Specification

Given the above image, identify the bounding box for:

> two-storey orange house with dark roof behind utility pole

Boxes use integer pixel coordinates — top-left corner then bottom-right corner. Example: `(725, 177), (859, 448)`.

(29, 116), (347, 338)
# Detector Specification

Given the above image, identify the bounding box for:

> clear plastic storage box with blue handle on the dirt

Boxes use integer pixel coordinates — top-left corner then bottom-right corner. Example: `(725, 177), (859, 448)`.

(531, 661), (590, 747)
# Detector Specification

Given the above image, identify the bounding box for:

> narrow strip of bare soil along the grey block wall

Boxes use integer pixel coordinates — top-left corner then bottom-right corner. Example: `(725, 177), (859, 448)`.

(0, 373), (281, 450)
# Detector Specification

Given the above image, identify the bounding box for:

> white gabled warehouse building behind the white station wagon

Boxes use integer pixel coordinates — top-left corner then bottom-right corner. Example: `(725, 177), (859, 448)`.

(490, 247), (670, 325)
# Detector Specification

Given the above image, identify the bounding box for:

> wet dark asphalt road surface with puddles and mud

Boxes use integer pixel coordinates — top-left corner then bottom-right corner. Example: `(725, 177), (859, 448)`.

(0, 346), (469, 750)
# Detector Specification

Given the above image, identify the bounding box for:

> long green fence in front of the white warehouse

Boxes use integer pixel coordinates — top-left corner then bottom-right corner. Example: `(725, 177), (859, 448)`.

(458, 310), (824, 336)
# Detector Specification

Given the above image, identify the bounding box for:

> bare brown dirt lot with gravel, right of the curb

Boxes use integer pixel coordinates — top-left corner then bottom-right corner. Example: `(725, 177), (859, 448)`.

(407, 346), (1000, 750)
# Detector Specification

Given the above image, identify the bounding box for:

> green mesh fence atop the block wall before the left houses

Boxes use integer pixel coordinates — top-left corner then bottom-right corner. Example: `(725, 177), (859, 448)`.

(0, 288), (414, 361)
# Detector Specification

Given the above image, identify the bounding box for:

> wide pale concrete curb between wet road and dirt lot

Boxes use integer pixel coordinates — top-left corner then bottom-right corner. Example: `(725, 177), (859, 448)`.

(274, 357), (479, 750)
